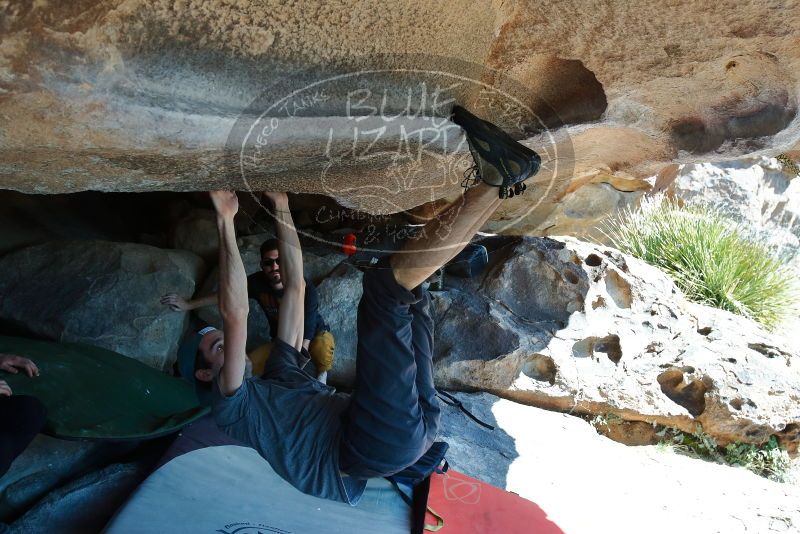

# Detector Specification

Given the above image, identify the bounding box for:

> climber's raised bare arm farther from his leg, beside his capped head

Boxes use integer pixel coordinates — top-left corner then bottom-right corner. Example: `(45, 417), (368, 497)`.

(211, 191), (249, 396)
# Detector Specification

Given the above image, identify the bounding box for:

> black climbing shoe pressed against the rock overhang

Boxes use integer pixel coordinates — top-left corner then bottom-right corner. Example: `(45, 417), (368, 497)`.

(452, 106), (542, 198)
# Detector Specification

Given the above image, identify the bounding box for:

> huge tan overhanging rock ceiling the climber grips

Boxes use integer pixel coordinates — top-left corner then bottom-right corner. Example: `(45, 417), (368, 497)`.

(0, 0), (800, 232)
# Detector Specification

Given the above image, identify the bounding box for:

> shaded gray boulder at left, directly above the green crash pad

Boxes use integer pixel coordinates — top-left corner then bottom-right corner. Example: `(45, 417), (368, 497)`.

(0, 241), (203, 370)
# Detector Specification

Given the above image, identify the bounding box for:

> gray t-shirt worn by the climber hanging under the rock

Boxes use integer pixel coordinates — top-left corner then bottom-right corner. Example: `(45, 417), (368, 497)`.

(212, 368), (366, 505)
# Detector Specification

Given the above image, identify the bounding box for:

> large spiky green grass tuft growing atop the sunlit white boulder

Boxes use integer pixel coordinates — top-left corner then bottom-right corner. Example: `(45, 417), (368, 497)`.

(603, 197), (798, 330)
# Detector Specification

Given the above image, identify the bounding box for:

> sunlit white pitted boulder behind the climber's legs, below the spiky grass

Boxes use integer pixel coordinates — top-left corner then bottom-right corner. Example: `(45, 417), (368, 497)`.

(320, 238), (800, 452)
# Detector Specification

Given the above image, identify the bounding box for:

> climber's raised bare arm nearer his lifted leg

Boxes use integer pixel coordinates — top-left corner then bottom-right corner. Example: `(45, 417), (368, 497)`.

(264, 192), (306, 350)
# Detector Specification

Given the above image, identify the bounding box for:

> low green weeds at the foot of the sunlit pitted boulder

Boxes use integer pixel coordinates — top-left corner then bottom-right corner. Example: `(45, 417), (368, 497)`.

(656, 425), (792, 482)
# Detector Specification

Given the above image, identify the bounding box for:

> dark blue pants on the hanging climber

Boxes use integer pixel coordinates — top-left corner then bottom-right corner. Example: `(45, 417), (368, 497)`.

(339, 264), (440, 478)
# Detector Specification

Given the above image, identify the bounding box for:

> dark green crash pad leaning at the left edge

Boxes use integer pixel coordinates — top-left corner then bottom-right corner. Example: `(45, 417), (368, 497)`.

(0, 336), (208, 440)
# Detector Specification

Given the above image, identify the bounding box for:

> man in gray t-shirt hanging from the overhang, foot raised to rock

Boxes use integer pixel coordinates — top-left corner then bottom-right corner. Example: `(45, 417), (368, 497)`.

(201, 108), (540, 505)
